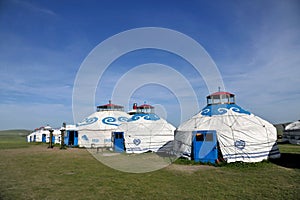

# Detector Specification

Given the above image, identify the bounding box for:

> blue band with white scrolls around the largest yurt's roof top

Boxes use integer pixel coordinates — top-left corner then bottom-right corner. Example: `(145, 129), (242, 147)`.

(200, 104), (251, 116)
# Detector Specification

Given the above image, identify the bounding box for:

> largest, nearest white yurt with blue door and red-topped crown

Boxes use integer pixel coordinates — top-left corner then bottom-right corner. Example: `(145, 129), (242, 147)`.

(174, 91), (280, 163)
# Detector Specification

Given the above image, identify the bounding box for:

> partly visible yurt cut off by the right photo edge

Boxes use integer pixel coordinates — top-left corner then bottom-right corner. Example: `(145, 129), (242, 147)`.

(282, 120), (300, 144)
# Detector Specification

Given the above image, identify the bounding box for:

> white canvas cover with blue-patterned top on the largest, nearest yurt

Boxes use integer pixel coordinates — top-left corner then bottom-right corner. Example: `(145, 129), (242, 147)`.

(174, 104), (280, 163)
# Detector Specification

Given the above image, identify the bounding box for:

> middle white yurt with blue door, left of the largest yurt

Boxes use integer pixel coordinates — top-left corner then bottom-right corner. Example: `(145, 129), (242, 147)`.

(113, 104), (175, 153)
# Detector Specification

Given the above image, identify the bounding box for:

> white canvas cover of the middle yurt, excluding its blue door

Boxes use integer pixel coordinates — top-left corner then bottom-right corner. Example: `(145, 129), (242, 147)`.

(116, 113), (175, 153)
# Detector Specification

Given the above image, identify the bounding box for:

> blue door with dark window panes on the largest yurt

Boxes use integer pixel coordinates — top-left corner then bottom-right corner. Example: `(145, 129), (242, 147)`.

(192, 130), (218, 163)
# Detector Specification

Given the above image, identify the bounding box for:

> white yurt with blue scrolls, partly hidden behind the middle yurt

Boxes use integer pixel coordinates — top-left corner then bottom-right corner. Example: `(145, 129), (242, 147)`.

(76, 101), (130, 148)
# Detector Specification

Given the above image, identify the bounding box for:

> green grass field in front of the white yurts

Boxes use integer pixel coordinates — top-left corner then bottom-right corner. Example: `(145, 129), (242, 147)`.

(0, 130), (300, 200)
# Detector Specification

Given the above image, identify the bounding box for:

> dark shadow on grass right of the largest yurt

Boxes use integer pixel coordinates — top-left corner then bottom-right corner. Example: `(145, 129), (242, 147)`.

(270, 153), (300, 169)
